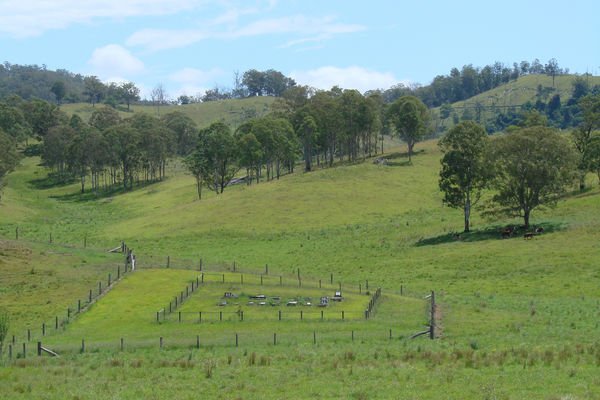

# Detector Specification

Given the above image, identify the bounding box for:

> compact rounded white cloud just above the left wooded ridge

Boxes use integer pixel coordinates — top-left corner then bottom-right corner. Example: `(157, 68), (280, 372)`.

(88, 44), (145, 79)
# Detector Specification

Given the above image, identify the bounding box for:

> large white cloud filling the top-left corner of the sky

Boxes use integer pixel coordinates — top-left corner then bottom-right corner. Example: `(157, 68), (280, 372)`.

(0, 0), (202, 37)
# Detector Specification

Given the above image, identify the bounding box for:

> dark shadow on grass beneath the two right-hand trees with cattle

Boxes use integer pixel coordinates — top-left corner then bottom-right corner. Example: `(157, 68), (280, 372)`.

(415, 222), (566, 247)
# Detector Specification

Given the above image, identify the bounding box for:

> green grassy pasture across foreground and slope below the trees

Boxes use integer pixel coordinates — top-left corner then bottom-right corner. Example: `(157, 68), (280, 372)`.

(0, 134), (600, 399)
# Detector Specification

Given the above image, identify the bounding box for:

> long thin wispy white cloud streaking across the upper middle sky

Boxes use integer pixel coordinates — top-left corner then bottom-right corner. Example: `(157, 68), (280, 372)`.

(125, 10), (366, 52)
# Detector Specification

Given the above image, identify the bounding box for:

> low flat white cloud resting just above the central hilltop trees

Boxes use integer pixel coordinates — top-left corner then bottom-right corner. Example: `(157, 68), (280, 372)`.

(290, 66), (402, 93)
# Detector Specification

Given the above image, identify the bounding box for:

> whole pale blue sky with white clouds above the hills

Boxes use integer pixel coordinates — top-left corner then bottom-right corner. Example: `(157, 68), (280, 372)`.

(0, 0), (600, 97)
